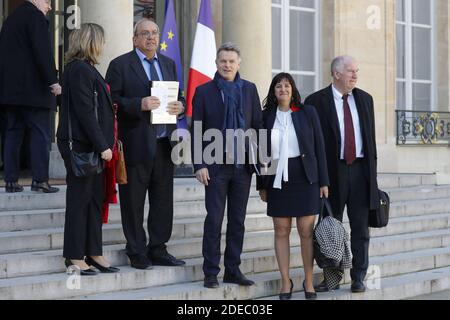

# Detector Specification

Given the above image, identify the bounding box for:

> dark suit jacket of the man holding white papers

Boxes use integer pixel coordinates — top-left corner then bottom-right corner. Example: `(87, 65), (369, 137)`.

(106, 50), (184, 166)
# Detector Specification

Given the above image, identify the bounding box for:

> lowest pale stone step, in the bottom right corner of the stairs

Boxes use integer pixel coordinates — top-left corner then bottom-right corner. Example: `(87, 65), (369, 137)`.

(260, 267), (450, 301)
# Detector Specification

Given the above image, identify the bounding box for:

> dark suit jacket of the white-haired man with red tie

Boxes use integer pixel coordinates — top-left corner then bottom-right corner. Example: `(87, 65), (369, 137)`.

(305, 85), (379, 210)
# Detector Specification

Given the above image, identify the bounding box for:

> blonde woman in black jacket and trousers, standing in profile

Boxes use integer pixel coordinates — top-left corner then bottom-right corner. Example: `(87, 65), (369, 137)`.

(57, 23), (119, 275)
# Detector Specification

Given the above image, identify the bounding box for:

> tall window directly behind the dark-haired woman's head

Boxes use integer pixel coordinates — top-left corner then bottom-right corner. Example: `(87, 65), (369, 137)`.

(272, 0), (320, 97)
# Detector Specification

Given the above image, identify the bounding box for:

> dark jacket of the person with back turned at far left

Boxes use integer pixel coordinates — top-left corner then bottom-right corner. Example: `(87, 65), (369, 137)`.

(0, 1), (58, 108)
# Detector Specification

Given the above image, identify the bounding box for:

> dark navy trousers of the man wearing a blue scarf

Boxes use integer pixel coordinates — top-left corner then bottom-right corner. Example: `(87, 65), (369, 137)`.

(202, 165), (252, 276)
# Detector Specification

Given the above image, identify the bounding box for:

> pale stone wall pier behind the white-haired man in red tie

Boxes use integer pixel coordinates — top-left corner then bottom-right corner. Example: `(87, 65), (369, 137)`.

(323, 0), (396, 171)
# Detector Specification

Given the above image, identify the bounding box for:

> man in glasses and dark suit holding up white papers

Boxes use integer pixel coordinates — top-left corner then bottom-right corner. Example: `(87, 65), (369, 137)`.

(106, 19), (185, 269)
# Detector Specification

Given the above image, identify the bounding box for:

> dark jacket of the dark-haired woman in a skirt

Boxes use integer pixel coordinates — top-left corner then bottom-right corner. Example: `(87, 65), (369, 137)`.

(257, 106), (329, 190)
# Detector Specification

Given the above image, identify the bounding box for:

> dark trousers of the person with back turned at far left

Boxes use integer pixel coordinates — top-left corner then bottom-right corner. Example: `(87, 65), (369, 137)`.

(4, 106), (51, 182)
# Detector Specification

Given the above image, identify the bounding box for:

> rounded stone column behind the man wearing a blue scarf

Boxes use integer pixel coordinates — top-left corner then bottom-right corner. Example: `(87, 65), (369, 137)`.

(222, 0), (272, 99)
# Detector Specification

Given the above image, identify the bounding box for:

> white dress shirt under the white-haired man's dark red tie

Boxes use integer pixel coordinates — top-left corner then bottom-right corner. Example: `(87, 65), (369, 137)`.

(332, 85), (364, 160)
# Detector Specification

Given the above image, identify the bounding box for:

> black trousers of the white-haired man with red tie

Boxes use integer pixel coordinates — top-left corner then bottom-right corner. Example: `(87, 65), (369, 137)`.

(330, 159), (370, 281)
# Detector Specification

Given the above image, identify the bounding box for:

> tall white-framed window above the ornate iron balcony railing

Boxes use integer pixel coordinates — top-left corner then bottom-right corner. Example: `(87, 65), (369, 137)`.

(396, 0), (436, 111)
